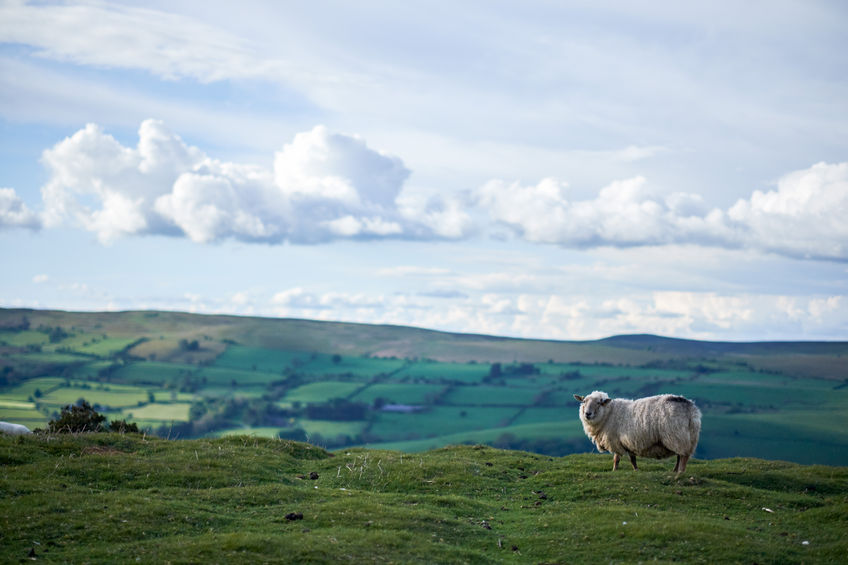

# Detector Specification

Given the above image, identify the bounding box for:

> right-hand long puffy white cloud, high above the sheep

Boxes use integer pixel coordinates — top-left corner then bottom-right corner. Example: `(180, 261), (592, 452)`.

(474, 163), (848, 261)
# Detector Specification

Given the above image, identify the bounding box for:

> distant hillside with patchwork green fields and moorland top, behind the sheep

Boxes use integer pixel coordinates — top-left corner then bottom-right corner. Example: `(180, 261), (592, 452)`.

(0, 309), (848, 465)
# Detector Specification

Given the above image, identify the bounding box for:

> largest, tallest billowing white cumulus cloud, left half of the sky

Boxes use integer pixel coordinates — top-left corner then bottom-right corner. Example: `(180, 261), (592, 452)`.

(42, 120), (470, 243)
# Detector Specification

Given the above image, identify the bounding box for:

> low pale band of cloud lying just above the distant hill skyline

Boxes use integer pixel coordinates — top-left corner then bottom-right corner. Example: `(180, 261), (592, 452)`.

(262, 288), (848, 339)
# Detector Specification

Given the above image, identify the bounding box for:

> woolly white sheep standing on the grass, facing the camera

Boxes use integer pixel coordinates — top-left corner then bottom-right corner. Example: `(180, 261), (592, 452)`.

(574, 391), (701, 475)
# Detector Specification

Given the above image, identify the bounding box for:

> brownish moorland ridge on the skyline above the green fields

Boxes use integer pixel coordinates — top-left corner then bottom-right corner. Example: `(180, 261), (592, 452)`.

(0, 308), (848, 372)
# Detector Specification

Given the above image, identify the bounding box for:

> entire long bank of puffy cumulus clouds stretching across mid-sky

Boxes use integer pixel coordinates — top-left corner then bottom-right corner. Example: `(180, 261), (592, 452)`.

(18, 120), (848, 261)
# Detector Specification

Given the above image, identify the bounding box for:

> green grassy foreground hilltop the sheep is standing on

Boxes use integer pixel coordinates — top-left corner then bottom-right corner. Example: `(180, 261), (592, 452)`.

(0, 434), (848, 563)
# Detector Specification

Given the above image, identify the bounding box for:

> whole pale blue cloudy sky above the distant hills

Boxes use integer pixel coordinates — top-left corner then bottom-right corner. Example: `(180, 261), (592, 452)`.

(0, 0), (848, 341)
